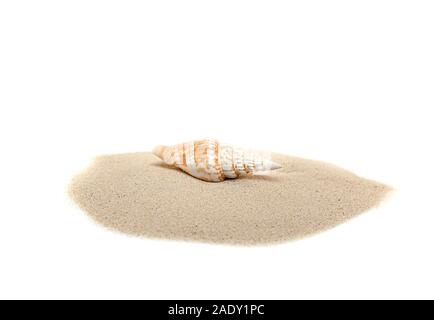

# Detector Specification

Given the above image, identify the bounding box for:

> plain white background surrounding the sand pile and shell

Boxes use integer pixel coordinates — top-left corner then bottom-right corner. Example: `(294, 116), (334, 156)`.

(0, 0), (434, 299)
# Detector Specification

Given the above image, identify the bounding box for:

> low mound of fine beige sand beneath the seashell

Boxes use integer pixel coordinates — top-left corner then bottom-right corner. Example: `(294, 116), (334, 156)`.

(69, 153), (389, 244)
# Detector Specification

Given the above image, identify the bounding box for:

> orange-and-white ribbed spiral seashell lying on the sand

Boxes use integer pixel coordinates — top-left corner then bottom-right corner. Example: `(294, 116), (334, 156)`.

(153, 139), (281, 182)
